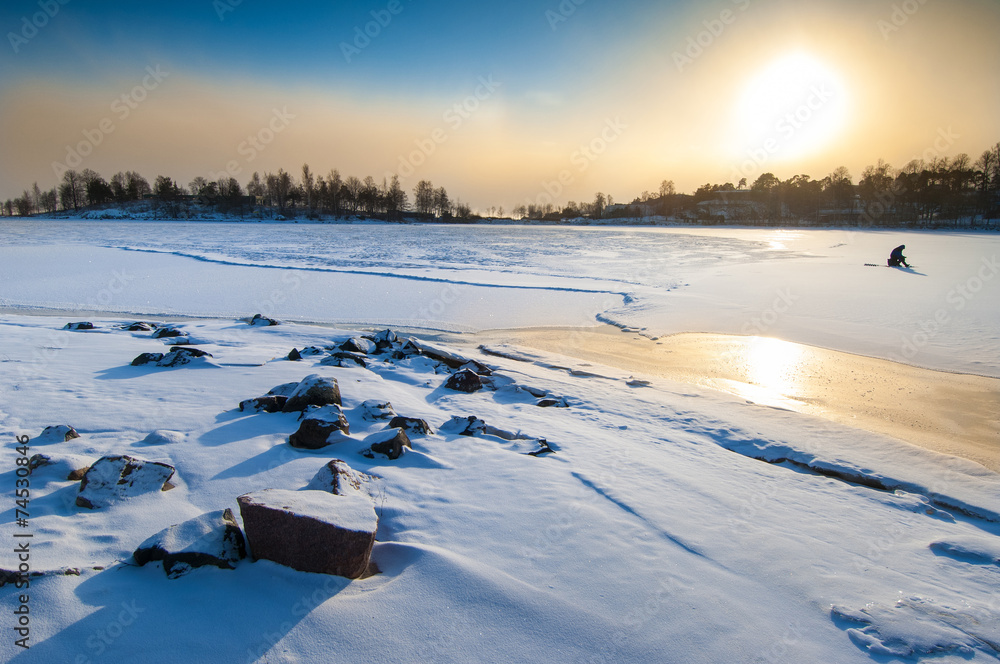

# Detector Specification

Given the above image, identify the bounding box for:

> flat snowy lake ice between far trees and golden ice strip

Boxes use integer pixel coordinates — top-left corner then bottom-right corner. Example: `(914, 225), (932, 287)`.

(0, 220), (1000, 376)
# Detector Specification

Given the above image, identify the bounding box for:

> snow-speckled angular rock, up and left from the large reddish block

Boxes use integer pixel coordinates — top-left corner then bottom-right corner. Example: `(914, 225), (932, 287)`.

(76, 454), (174, 509)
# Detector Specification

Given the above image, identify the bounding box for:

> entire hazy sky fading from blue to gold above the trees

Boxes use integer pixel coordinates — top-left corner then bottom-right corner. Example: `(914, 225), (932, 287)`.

(0, 0), (1000, 210)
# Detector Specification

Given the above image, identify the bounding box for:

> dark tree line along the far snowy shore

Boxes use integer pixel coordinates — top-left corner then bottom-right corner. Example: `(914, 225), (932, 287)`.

(0, 143), (1000, 226)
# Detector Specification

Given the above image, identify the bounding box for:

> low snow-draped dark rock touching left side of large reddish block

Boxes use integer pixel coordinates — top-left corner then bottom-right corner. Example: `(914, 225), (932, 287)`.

(132, 509), (247, 579)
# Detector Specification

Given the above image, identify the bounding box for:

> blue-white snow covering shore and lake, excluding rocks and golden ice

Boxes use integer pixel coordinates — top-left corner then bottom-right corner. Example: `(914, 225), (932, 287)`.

(0, 222), (1000, 663)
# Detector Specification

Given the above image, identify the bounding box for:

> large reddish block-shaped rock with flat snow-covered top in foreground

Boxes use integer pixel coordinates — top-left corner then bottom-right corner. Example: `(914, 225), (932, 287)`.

(237, 489), (378, 579)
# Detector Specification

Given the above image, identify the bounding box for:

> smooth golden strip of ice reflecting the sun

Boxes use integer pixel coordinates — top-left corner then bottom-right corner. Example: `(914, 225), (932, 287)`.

(473, 325), (1000, 473)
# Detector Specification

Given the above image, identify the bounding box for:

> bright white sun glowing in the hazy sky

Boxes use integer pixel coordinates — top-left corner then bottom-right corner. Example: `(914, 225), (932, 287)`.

(733, 52), (850, 165)
